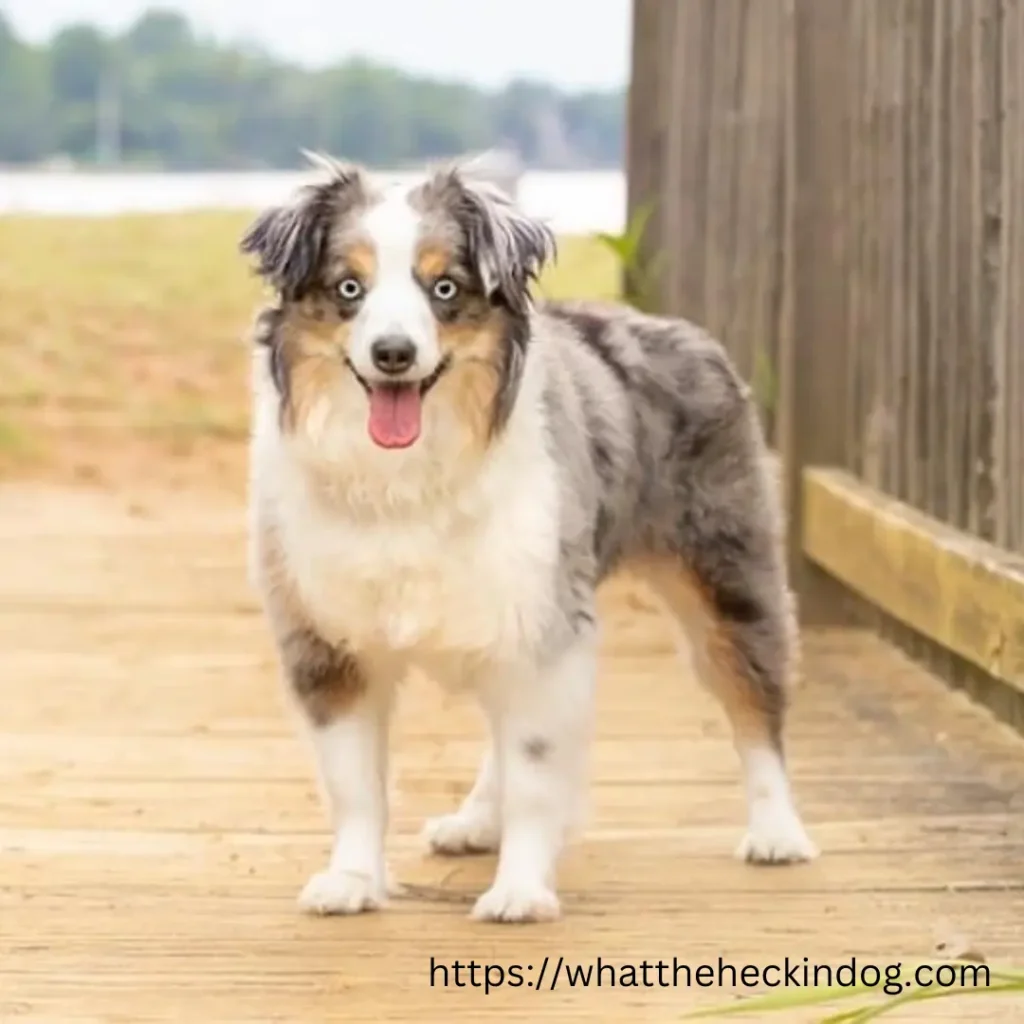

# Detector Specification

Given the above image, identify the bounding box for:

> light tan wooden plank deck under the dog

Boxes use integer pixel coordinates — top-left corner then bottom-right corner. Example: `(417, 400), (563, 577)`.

(0, 490), (1024, 1024)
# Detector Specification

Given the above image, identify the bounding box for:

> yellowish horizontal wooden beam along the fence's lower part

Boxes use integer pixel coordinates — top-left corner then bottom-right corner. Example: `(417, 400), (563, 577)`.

(803, 467), (1024, 692)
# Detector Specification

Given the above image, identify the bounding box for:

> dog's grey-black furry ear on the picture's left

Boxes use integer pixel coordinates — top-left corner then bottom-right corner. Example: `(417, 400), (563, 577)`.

(240, 154), (365, 300)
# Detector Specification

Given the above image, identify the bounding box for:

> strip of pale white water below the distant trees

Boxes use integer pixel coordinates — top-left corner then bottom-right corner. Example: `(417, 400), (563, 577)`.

(0, 171), (626, 234)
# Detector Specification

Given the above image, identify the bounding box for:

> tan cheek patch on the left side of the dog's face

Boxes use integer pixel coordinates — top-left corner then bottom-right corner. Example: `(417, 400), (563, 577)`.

(278, 300), (351, 432)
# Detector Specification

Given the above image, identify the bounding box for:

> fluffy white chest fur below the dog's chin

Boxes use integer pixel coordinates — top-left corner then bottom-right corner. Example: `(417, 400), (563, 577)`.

(254, 391), (559, 684)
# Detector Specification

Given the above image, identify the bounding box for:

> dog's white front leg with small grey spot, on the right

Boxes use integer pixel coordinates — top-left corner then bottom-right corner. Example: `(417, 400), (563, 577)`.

(473, 633), (596, 922)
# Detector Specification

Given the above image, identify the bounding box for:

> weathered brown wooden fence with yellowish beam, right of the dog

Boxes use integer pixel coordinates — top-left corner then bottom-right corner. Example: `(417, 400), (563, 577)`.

(628, 0), (1024, 726)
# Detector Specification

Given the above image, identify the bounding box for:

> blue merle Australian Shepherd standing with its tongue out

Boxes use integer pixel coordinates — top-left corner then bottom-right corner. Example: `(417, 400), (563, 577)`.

(240, 155), (817, 922)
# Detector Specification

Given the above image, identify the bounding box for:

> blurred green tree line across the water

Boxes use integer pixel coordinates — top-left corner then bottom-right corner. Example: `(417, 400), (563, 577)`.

(0, 10), (624, 169)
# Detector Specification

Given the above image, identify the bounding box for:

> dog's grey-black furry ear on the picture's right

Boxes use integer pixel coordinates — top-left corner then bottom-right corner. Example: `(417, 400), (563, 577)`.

(433, 167), (557, 315)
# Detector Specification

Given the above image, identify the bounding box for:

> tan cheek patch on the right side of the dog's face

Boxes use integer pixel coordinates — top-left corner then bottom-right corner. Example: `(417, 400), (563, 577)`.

(427, 312), (505, 449)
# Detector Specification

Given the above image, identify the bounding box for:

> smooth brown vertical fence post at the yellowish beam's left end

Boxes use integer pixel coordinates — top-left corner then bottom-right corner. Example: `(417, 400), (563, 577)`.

(777, 0), (848, 625)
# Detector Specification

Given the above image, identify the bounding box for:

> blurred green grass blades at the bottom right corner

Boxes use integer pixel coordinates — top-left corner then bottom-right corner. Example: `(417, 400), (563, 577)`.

(684, 961), (1024, 1024)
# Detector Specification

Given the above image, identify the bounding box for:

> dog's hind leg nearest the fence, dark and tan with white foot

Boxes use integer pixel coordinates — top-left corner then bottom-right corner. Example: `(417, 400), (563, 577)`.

(644, 552), (817, 863)
